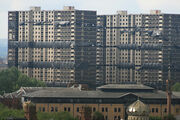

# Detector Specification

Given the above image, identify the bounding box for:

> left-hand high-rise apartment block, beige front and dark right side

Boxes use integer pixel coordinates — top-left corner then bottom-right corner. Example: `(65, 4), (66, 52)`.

(8, 6), (97, 85)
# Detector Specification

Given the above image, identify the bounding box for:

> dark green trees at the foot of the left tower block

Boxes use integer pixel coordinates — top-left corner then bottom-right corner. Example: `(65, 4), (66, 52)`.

(0, 67), (45, 94)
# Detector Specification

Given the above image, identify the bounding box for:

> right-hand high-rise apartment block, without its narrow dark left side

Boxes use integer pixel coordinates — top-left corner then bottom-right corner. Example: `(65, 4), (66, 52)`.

(105, 10), (180, 87)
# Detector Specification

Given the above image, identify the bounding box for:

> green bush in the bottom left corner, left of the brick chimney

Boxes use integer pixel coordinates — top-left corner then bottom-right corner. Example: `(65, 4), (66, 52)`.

(0, 104), (24, 120)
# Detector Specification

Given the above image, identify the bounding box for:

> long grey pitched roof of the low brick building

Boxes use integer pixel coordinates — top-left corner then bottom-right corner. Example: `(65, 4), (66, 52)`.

(24, 88), (180, 99)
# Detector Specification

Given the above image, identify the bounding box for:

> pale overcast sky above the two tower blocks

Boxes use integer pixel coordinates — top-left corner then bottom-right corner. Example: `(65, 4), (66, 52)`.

(0, 0), (180, 40)
